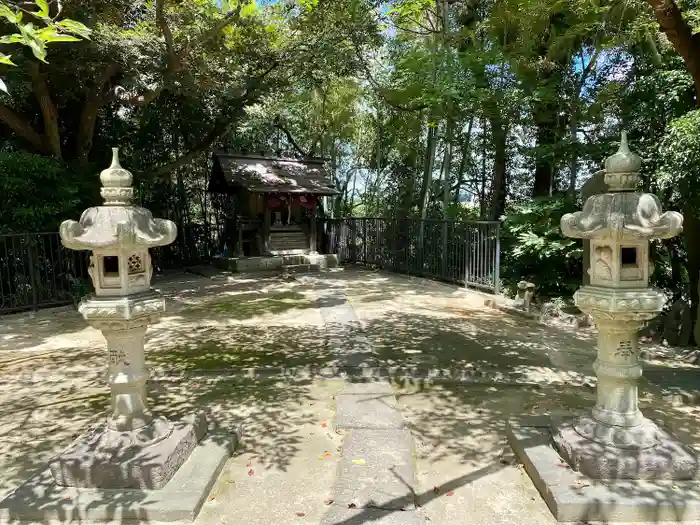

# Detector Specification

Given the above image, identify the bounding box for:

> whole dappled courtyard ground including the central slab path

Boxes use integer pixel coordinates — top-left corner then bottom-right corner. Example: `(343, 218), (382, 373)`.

(0, 271), (700, 525)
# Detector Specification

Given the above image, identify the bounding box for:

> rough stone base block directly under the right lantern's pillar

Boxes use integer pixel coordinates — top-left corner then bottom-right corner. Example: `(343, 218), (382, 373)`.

(552, 417), (700, 480)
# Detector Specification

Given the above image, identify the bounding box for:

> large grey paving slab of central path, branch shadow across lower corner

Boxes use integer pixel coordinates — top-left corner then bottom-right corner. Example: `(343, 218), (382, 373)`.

(334, 429), (415, 510)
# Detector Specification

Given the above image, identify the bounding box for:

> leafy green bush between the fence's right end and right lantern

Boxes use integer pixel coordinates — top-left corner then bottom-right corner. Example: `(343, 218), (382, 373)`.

(501, 197), (583, 298)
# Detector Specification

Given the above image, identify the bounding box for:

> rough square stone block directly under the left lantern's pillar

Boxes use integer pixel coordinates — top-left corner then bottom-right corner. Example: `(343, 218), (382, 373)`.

(49, 413), (207, 490)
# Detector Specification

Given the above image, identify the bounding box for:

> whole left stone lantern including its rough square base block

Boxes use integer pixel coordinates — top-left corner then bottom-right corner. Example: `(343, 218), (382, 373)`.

(49, 148), (206, 489)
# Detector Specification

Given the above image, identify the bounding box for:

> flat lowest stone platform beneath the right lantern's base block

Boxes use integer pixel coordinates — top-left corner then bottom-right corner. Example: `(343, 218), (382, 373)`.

(507, 416), (700, 523)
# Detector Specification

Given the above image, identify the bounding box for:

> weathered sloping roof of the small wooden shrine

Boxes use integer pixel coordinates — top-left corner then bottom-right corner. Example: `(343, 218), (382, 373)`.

(209, 152), (338, 195)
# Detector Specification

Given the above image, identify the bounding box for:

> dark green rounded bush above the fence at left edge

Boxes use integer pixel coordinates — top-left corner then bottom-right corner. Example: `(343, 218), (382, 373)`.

(0, 151), (84, 233)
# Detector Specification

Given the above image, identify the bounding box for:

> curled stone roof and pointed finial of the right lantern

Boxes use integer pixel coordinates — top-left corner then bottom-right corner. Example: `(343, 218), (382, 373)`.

(561, 132), (683, 242)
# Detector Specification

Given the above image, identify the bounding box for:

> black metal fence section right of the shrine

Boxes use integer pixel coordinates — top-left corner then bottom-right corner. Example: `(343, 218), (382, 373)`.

(319, 218), (501, 294)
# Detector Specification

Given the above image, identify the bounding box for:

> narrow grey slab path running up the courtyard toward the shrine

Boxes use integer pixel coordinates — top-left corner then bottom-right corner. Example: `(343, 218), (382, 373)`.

(317, 281), (424, 525)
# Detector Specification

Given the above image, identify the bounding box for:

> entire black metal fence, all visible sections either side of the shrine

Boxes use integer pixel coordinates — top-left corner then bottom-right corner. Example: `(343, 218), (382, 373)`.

(0, 218), (500, 314)
